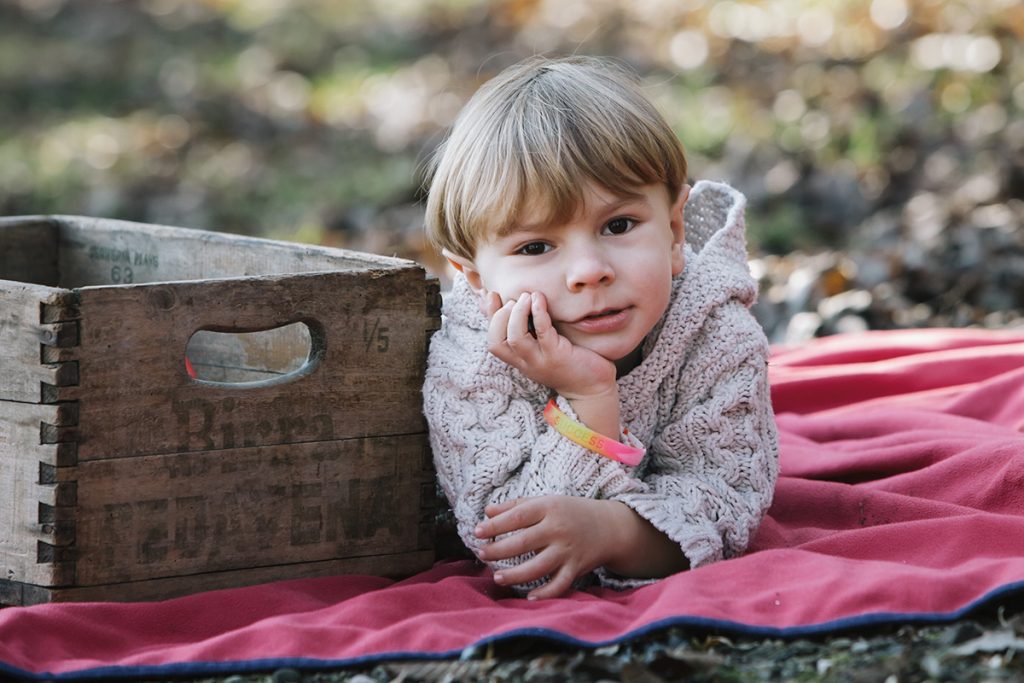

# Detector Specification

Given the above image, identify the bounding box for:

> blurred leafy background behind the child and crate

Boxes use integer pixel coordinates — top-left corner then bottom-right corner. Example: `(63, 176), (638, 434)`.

(0, 0), (1024, 343)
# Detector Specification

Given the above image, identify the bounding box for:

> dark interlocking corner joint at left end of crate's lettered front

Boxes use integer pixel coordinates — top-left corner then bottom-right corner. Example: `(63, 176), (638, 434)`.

(36, 292), (81, 585)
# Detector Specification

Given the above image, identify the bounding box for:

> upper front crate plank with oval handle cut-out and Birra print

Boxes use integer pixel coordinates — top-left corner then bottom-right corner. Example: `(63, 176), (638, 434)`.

(58, 268), (431, 460)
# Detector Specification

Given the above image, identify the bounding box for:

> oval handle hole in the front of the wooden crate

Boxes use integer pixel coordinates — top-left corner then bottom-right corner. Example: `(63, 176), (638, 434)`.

(184, 323), (323, 386)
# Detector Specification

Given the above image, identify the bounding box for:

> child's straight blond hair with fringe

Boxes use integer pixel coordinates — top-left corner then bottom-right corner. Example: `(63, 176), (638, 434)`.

(426, 57), (686, 258)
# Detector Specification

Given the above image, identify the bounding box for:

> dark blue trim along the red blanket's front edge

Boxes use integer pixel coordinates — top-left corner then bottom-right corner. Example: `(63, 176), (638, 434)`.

(6, 581), (1024, 681)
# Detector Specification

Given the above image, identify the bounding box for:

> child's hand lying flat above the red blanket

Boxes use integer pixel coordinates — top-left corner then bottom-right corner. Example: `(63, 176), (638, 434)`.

(474, 496), (625, 599)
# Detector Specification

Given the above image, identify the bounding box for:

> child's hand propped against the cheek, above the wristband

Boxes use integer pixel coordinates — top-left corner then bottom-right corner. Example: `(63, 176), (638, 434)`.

(480, 292), (618, 401)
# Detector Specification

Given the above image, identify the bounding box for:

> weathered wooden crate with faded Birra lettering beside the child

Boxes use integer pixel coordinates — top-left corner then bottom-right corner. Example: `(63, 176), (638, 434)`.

(0, 216), (440, 604)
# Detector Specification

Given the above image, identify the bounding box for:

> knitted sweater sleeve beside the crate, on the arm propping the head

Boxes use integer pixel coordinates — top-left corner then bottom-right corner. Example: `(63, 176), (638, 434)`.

(423, 321), (647, 585)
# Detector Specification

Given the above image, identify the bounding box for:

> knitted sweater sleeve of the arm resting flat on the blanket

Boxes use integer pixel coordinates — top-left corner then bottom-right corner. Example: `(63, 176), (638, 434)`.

(602, 302), (778, 585)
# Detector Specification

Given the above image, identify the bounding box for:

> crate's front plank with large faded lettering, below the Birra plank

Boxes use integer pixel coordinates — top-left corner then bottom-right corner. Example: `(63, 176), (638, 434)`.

(75, 434), (433, 586)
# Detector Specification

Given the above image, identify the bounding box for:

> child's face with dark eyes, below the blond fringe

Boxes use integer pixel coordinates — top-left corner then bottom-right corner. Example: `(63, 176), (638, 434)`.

(450, 184), (689, 361)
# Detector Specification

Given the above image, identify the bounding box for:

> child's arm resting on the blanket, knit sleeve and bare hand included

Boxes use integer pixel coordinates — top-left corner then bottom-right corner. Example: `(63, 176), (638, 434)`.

(476, 333), (777, 597)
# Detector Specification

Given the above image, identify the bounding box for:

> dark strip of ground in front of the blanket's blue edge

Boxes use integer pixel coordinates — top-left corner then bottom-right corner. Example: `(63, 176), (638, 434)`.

(153, 603), (1024, 683)
